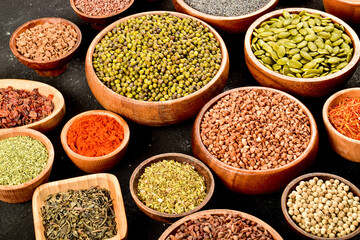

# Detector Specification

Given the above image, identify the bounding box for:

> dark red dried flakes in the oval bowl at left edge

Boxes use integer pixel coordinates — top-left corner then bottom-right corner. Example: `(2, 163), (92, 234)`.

(0, 86), (54, 129)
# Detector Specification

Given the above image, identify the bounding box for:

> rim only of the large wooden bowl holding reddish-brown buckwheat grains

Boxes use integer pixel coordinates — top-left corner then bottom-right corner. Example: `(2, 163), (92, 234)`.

(193, 86), (318, 174)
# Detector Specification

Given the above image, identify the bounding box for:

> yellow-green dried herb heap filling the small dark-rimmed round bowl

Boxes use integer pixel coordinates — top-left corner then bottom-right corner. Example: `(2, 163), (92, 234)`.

(138, 160), (206, 214)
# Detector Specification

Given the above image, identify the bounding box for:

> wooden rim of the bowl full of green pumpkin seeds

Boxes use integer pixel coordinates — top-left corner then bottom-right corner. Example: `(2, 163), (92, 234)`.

(244, 7), (360, 83)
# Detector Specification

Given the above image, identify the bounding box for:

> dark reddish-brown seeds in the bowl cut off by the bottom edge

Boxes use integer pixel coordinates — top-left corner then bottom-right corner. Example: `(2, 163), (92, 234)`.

(166, 214), (274, 240)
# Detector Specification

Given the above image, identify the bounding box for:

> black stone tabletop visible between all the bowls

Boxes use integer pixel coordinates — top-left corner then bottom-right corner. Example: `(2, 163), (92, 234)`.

(0, 0), (360, 240)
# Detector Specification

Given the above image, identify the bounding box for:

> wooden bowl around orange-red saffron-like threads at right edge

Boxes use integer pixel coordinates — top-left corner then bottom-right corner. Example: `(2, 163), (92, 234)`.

(323, 88), (360, 162)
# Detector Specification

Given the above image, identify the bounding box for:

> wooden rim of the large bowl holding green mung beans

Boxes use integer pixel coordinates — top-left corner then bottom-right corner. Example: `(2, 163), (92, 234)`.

(85, 11), (229, 107)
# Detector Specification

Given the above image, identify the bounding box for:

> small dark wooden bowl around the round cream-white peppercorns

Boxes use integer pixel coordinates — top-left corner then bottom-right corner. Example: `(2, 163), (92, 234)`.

(281, 172), (360, 240)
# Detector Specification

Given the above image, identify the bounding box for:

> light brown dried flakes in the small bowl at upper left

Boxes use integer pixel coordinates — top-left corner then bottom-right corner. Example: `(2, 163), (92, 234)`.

(16, 23), (77, 61)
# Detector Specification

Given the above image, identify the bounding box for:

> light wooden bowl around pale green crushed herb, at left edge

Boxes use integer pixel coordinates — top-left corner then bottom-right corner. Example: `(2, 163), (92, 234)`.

(0, 128), (54, 203)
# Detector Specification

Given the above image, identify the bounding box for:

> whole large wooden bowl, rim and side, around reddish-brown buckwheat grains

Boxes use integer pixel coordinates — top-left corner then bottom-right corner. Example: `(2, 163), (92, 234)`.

(191, 87), (319, 195)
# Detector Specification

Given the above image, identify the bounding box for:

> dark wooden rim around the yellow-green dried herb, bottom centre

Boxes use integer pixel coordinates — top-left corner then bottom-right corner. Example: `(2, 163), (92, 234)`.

(129, 152), (215, 219)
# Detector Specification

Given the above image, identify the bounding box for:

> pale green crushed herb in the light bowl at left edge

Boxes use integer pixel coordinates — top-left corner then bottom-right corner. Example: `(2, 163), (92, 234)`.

(0, 136), (49, 185)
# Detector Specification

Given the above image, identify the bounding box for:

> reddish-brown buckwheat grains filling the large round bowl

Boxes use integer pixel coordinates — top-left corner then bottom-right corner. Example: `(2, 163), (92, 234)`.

(200, 89), (311, 170)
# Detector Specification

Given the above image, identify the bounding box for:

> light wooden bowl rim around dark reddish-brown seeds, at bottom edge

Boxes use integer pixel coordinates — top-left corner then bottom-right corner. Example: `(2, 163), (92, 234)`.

(159, 209), (283, 240)
